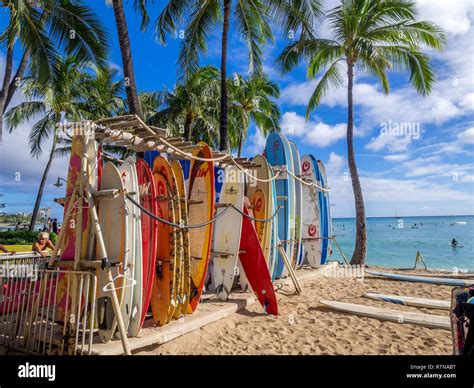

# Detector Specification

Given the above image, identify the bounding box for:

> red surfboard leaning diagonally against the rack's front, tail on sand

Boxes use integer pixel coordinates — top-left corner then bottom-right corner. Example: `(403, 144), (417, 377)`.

(239, 206), (278, 315)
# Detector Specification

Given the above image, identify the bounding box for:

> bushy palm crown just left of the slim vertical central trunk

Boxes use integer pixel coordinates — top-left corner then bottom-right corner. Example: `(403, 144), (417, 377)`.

(145, 66), (220, 144)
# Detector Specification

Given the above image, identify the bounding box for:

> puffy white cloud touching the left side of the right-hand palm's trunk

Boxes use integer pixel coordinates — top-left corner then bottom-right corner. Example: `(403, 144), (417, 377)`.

(281, 112), (347, 147)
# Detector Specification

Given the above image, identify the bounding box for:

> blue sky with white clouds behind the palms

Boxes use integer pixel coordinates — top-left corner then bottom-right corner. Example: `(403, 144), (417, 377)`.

(0, 0), (474, 217)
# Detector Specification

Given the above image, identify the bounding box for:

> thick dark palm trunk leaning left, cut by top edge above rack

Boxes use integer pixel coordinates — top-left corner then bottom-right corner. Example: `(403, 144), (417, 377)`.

(112, 0), (141, 116)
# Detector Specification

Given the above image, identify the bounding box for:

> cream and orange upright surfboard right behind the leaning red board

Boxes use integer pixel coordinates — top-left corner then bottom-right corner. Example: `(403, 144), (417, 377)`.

(246, 155), (276, 273)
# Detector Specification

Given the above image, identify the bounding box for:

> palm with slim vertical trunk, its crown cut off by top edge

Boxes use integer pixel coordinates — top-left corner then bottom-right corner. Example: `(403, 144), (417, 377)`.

(155, 0), (321, 150)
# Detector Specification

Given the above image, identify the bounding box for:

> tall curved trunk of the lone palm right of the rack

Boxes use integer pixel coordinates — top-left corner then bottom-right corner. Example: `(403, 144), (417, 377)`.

(347, 62), (367, 265)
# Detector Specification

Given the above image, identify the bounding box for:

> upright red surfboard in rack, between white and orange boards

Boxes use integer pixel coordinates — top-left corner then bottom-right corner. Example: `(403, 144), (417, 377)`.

(137, 159), (158, 327)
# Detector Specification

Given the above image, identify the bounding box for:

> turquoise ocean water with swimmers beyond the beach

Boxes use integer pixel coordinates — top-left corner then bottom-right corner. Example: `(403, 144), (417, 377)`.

(330, 216), (474, 271)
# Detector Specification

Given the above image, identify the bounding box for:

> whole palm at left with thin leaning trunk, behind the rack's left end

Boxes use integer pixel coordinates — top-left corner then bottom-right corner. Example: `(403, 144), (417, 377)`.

(5, 56), (123, 230)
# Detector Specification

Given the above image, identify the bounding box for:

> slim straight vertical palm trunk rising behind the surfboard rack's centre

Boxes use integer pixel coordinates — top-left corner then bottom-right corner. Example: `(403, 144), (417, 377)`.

(219, 0), (231, 151)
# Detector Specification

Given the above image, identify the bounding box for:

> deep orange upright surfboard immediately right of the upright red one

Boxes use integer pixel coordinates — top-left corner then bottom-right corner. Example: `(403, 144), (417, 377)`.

(151, 156), (176, 326)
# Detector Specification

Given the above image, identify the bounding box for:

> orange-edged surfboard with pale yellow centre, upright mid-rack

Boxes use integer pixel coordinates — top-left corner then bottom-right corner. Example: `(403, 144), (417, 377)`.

(188, 144), (215, 314)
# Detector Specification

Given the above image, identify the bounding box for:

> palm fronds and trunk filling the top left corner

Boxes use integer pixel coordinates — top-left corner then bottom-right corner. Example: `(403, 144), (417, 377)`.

(0, 0), (107, 140)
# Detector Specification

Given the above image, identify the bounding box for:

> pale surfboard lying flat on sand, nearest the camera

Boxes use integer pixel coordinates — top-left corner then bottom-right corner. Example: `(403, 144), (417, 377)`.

(319, 300), (450, 330)
